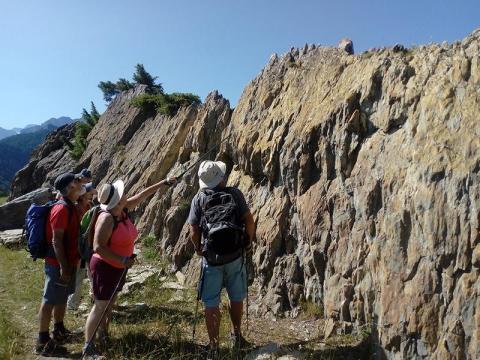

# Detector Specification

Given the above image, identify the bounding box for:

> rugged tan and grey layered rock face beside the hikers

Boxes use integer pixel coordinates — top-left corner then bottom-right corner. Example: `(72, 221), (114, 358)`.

(7, 30), (480, 359)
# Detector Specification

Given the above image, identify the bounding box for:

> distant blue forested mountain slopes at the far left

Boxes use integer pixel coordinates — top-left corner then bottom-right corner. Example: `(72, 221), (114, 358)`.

(0, 116), (77, 193)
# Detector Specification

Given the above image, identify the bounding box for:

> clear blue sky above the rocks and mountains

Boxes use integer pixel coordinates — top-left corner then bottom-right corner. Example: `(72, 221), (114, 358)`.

(0, 0), (480, 128)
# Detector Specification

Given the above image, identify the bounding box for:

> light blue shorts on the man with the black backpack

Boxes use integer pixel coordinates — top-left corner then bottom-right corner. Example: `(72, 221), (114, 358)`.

(199, 257), (247, 308)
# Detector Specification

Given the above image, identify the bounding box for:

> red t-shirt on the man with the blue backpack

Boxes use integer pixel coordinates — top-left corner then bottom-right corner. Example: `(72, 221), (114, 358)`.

(45, 198), (80, 266)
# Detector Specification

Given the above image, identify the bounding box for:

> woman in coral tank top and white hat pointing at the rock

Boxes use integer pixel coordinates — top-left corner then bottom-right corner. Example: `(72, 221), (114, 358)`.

(83, 178), (177, 358)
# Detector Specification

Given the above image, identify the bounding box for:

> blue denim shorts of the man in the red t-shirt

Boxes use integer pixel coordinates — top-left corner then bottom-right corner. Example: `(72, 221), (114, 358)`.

(43, 263), (75, 305)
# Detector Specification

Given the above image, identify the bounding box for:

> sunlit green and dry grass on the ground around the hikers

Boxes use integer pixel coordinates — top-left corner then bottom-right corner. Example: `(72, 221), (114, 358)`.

(0, 246), (369, 360)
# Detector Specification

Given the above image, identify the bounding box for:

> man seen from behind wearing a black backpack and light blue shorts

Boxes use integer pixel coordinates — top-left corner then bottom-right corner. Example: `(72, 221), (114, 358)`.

(188, 161), (255, 357)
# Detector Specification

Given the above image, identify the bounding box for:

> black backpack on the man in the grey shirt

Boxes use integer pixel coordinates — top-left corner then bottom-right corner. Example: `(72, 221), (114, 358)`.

(200, 188), (246, 265)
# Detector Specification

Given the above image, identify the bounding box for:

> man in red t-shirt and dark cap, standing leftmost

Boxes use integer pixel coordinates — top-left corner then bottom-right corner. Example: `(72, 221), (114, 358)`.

(35, 173), (82, 355)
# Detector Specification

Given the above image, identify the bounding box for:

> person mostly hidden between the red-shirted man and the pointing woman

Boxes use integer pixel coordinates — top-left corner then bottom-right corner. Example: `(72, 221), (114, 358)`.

(67, 184), (97, 311)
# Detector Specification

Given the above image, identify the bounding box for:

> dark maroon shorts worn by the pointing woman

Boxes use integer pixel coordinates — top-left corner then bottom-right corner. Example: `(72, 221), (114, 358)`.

(90, 256), (126, 300)
